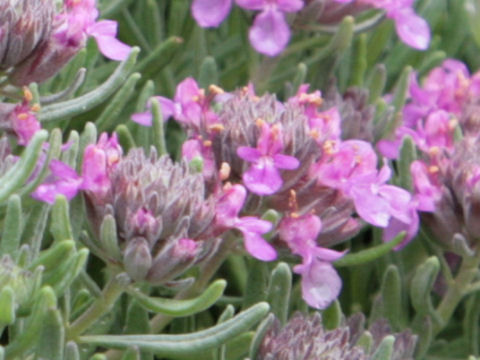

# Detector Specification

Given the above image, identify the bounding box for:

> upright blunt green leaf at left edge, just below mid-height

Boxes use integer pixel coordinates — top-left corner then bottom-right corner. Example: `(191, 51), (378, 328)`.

(0, 195), (23, 259)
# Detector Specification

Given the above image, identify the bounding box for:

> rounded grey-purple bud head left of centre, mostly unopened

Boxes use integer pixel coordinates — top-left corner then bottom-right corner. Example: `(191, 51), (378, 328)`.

(85, 149), (218, 284)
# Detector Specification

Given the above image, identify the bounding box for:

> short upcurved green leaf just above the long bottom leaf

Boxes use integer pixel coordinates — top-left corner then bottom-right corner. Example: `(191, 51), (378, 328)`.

(128, 280), (227, 316)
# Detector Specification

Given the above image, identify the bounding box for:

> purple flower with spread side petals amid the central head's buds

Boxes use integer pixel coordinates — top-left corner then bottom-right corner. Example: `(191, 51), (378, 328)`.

(237, 121), (300, 195)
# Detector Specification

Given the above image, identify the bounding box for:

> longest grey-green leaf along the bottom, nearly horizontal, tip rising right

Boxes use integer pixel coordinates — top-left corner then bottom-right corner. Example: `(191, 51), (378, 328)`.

(79, 303), (269, 357)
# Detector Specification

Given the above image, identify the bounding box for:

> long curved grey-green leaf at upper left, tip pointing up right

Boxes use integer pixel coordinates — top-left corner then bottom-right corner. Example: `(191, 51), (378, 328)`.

(38, 47), (140, 122)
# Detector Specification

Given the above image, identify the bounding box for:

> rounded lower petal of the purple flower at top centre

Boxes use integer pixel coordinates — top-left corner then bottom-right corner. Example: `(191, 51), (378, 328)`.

(249, 9), (290, 56)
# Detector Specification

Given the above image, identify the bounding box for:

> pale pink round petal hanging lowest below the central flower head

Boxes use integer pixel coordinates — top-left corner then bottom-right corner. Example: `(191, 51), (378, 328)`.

(294, 260), (342, 309)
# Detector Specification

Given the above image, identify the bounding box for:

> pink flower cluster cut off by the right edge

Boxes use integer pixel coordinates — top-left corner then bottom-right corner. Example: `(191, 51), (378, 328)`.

(378, 59), (480, 250)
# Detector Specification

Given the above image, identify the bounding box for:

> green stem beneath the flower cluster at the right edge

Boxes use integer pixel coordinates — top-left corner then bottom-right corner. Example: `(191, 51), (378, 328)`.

(433, 254), (480, 334)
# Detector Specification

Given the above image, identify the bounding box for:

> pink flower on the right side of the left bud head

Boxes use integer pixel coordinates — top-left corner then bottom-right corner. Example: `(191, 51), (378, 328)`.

(216, 184), (277, 261)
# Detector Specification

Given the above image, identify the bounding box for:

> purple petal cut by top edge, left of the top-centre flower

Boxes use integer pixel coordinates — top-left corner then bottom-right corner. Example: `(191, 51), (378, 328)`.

(192, 0), (232, 27)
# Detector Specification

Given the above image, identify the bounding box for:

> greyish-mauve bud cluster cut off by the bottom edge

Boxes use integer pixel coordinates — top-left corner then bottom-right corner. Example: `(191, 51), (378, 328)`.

(256, 313), (417, 360)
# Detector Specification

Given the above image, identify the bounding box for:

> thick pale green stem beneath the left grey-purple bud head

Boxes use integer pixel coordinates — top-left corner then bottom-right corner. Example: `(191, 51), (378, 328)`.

(67, 274), (125, 341)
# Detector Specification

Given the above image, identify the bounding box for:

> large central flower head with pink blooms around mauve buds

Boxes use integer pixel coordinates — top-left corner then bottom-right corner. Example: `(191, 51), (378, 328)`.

(133, 78), (418, 308)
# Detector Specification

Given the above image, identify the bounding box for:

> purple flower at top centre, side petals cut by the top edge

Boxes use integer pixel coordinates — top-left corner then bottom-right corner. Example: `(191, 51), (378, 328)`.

(237, 0), (303, 56)
